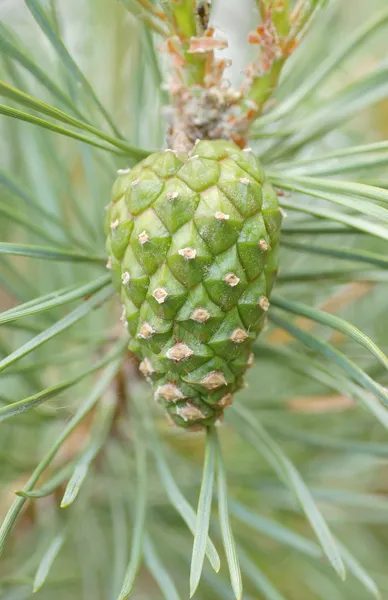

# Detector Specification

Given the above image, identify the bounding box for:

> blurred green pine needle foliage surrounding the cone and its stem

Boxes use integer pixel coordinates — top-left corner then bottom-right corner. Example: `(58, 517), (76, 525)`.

(0, 0), (388, 600)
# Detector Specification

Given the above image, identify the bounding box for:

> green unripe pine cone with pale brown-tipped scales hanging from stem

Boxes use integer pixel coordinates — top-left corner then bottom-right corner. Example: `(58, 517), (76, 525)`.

(106, 140), (281, 429)
